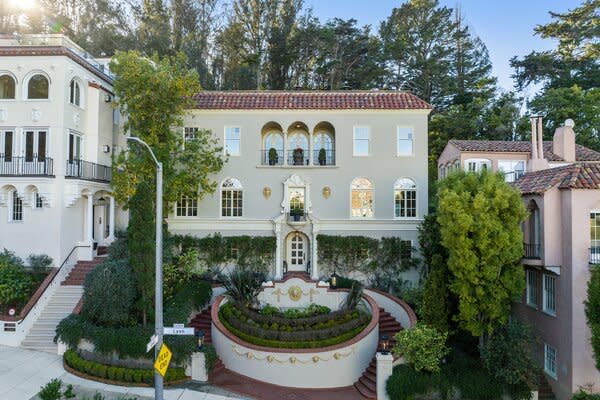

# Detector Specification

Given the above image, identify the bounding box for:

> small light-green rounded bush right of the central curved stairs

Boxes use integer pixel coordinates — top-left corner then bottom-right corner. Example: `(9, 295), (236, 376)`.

(392, 324), (448, 372)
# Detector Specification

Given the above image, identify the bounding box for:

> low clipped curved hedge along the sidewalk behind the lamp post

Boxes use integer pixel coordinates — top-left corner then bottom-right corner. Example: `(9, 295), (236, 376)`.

(64, 350), (188, 385)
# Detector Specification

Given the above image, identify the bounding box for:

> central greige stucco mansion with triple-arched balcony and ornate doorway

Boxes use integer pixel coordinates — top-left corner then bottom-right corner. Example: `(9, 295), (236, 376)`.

(169, 91), (431, 279)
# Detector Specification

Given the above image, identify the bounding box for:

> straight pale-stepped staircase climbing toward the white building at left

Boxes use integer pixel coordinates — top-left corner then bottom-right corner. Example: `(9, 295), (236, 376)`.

(21, 257), (105, 353)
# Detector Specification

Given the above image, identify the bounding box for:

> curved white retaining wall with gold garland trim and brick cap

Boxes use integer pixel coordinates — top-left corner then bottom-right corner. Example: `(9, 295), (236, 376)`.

(211, 295), (379, 388)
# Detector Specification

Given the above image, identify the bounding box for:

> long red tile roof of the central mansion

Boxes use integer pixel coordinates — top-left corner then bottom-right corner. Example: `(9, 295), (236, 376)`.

(192, 91), (432, 110)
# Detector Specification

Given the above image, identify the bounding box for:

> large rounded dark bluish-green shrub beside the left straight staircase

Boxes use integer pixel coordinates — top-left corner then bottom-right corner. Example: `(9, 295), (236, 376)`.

(81, 261), (136, 326)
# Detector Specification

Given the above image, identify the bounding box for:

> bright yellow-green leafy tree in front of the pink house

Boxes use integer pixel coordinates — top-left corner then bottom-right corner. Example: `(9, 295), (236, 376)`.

(438, 172), (526, 344)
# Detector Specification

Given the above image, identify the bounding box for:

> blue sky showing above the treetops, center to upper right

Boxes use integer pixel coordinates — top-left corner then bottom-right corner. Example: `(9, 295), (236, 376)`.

(305, 0), (582, 90)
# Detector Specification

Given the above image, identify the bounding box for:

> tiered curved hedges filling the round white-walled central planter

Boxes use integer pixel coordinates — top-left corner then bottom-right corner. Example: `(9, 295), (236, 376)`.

(219, 303), (371, 348)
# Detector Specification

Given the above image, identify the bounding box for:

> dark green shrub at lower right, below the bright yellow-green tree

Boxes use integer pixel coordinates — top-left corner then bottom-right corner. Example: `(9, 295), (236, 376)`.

(480, 320), (540, 387)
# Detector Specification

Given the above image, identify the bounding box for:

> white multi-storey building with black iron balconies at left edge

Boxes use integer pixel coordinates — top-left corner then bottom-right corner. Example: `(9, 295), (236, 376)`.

(0, 35), (124, 266)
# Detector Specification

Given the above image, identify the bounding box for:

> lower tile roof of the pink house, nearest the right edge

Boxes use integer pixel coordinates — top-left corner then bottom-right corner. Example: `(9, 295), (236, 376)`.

(513, 163), (600, 194)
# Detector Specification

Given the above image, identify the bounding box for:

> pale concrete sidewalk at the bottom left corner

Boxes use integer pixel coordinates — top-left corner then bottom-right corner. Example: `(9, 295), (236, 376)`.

(0, 346), (248, 400)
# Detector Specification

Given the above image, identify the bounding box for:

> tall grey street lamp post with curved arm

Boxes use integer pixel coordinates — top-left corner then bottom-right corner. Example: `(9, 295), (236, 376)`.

(127, 137), (164, 400)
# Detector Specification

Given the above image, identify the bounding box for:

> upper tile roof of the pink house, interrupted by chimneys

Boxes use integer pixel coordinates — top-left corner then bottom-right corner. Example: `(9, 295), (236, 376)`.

(449, 139), (600, 161)
